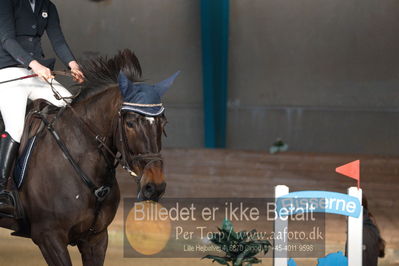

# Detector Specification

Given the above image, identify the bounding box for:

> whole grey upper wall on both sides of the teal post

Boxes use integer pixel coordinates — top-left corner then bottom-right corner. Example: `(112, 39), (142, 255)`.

(45, 0), (399, 155)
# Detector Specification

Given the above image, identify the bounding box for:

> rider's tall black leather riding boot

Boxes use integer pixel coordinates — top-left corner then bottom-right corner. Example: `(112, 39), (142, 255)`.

(0, 133), (19, 214)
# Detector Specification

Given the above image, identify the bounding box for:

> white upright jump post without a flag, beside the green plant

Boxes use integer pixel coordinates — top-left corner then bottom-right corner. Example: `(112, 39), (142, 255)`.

(273, 185), (289, 266)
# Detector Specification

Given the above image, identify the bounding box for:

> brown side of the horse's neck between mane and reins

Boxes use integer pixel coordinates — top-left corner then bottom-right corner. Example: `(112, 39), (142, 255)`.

(74, 87), (121, 137)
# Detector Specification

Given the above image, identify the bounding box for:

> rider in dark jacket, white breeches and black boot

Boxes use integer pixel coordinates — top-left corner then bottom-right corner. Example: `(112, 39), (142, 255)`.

(0, 0), (83, 213)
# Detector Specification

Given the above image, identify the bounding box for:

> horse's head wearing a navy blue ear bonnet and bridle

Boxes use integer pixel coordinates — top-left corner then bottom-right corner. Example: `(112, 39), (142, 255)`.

(117, 72), (178, 201)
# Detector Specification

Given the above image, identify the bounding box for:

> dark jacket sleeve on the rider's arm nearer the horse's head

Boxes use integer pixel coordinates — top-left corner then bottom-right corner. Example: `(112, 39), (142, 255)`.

(47, 0), (75, 66)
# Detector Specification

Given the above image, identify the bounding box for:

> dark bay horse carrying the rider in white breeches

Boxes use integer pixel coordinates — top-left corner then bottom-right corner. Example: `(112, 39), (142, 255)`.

(0, 50), (175, 266)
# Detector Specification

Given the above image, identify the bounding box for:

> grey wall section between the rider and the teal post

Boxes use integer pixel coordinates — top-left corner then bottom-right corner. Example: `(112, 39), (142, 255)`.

(43, 0), (203, 147)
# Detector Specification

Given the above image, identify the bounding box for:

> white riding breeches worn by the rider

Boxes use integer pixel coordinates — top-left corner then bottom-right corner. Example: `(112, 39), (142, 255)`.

(0, 67), (71, 142)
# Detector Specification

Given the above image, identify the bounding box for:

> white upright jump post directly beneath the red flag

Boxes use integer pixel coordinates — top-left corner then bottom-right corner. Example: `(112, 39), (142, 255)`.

(348, 187), (363, 266)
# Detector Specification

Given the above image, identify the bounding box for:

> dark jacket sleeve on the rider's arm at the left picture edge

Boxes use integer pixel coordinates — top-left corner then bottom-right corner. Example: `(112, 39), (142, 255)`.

(0, 0), (33, 67)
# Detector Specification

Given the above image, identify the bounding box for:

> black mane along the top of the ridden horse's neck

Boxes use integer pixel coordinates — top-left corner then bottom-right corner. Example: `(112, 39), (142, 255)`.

(74, 49), (142, 103)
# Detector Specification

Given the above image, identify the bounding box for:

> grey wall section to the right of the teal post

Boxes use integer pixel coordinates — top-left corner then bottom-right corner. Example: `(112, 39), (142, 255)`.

(228, 0), (399, 155)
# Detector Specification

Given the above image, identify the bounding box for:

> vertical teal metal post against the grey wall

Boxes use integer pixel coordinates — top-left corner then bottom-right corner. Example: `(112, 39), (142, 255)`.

(201, 0), (229, 148)
